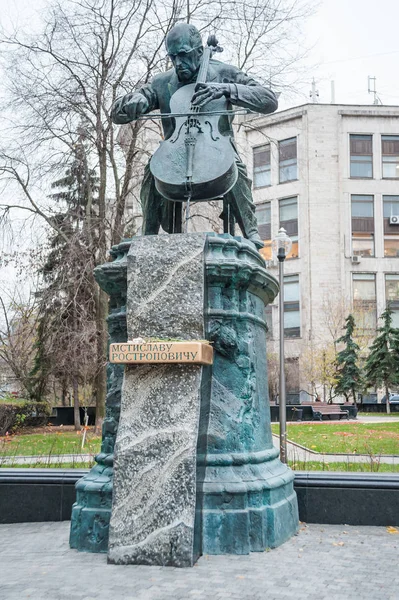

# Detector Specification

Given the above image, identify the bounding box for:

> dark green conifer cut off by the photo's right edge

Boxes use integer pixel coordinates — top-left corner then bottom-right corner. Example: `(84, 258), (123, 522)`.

(364, 305), (399, 413)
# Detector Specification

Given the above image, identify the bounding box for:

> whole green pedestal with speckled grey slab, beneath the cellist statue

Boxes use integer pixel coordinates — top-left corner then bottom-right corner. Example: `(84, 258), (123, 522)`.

(71, 234), (298, 565)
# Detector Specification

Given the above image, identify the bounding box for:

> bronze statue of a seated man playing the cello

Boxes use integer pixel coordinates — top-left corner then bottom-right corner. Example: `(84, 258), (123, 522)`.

(112, 24), (277, 247)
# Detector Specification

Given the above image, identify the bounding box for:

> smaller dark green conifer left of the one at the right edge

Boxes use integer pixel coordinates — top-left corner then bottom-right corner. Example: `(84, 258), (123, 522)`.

(335, 315), (362, 404)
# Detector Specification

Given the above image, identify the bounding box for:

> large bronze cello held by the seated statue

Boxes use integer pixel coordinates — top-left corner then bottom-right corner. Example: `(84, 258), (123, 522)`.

(150, 35), (238, 204)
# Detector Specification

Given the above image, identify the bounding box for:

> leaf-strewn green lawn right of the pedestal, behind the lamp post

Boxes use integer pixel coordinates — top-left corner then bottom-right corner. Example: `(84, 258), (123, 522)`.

(272, 422), (399, 455)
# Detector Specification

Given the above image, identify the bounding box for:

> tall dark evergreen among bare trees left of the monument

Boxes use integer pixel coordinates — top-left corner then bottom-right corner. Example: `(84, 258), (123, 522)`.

(32, 143), (98, 429)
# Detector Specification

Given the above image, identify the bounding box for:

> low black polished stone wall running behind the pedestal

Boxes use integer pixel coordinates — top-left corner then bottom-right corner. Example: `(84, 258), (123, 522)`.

(0, 469), (399, 525)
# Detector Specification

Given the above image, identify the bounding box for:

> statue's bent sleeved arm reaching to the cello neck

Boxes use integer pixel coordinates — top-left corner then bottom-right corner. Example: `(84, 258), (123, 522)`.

(229, 71), (278, 115)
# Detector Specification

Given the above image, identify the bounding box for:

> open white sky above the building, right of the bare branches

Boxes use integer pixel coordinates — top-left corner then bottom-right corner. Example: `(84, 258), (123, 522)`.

(306, 0), (399, 105)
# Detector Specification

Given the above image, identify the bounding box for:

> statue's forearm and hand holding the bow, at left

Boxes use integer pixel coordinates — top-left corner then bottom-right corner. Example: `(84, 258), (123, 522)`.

(111, 85), (159, 125)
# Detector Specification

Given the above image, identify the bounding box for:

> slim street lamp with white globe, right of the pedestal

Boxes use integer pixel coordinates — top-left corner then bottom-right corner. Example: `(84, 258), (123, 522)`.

(272, 227), (292, 463)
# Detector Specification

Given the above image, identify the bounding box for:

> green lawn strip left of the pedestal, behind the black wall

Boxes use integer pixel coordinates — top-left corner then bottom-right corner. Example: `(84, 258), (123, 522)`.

(0, 431), (101, 460)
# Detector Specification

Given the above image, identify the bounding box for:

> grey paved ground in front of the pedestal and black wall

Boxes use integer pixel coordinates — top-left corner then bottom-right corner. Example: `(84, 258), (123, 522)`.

(0, 522), (399, 600)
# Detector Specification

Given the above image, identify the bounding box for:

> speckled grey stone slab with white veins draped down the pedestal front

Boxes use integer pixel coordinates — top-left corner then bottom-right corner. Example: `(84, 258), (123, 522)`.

(108, 234), (206, 567)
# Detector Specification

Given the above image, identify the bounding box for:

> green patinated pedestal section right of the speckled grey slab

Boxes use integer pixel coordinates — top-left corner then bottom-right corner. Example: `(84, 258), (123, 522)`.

(202, 235), (298, 554)
